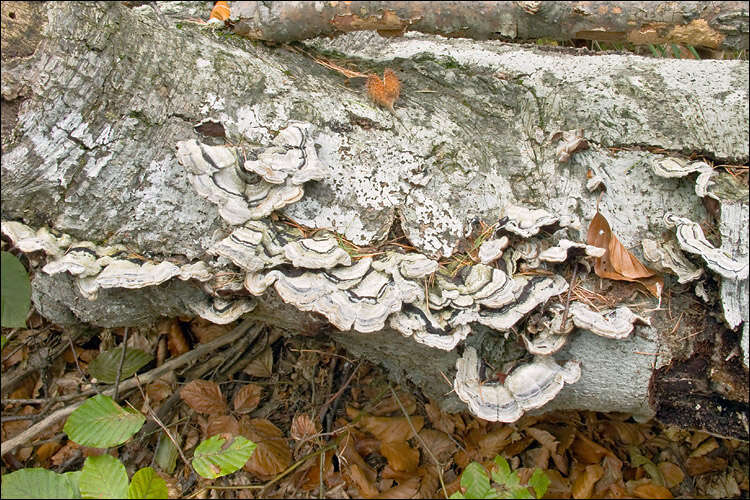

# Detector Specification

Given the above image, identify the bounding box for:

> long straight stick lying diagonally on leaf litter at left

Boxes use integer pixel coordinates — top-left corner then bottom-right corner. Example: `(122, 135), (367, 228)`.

(0, 318), (262, 455)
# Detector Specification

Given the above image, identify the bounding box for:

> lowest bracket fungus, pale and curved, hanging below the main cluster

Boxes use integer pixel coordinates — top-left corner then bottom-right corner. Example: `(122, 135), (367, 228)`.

(453, 346), (581, 423)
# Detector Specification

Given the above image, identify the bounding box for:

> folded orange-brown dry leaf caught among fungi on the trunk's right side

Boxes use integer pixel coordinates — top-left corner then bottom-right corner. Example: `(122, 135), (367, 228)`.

(586, 211), (664, 297)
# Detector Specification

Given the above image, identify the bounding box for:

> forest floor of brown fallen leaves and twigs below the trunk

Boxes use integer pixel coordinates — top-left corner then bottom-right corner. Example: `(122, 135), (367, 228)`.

(2, 313), (750, 498)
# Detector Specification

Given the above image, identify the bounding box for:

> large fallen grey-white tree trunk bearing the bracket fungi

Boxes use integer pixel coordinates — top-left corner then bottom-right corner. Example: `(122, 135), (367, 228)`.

(2, 2), (748, 439)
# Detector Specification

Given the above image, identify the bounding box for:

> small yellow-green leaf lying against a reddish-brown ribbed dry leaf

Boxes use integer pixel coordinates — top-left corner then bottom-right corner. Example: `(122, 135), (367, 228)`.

(193, 435), (256, 479)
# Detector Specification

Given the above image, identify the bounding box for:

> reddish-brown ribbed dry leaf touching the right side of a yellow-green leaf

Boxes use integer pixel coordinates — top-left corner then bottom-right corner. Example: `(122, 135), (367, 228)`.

(240, 416), (292, 480)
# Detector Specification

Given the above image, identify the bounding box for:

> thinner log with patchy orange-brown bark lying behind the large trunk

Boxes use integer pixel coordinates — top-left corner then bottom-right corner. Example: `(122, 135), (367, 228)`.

(231, 1), (748, 50)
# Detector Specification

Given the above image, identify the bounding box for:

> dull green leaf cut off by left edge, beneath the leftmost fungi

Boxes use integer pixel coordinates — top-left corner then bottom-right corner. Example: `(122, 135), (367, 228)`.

(0, 252), (31, 328)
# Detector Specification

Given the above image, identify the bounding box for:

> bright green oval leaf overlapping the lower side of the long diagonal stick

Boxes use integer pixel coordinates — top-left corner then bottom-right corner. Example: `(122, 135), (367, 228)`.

(63, 394), (146, 448)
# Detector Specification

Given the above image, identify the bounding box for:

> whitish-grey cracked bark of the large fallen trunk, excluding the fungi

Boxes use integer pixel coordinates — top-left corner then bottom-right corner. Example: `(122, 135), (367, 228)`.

(1, 2), (748, 439)
